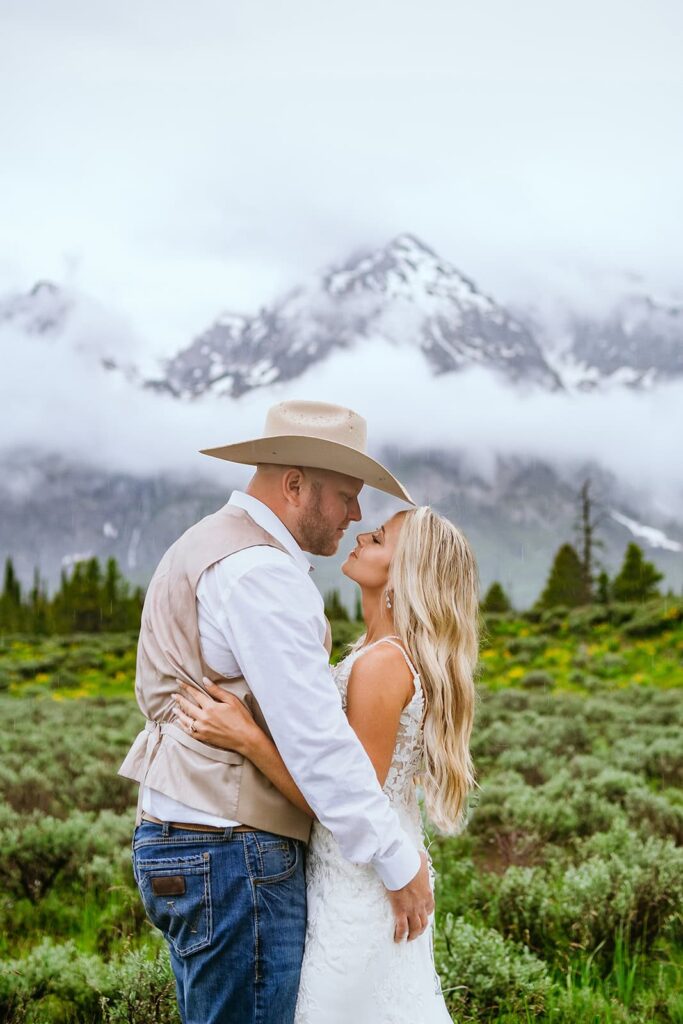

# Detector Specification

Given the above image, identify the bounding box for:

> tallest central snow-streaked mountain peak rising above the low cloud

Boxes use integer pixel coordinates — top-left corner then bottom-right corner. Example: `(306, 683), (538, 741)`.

(151, 234), (561, 397)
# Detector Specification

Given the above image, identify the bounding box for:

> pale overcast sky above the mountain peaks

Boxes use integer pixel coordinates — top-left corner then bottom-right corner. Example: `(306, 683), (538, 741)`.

(0, 0), (683, 353)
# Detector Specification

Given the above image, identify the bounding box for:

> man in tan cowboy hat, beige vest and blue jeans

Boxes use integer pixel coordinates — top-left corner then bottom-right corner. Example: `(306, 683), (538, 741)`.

(120, 401), (433, 1024)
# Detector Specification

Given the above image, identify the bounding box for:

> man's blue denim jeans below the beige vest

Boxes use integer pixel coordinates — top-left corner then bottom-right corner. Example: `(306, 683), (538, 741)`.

(133, 821), (306, 1024)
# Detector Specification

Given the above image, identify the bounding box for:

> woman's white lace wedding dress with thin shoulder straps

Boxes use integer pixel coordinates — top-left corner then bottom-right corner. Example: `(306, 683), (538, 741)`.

(295, 638), (451, 1024)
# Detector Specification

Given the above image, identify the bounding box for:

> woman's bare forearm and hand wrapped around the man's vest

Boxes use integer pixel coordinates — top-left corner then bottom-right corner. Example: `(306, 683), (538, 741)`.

(174, 678), (315, 818)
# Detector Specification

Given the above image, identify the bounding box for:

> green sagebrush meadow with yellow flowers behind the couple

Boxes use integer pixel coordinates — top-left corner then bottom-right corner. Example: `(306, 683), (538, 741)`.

(0, 600), (683, 1024)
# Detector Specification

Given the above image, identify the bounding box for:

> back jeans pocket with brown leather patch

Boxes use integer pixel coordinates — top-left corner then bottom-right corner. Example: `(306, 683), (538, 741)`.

(136, 853), (213, 956)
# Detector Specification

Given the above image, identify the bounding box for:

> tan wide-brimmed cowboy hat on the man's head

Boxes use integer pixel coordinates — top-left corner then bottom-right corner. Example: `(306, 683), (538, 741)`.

(202, 401), (415, 505)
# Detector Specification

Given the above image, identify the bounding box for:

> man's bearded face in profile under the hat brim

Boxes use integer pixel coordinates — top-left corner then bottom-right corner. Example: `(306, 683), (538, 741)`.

(297, 469), (362, 555)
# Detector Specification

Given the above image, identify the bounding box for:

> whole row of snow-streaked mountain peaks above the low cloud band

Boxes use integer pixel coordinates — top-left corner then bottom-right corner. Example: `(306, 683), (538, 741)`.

(5, 233), (683, 398)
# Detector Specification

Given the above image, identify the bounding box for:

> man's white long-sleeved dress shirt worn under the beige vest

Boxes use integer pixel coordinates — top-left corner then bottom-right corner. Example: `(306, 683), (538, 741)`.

(142, 490), (420, 889)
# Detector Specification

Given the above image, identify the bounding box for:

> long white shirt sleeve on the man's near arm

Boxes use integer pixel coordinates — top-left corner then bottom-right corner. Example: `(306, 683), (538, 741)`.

(211, 552), (420, 890)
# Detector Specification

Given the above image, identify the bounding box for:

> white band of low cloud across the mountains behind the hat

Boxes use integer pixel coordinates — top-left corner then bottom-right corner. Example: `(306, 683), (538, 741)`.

(0, 327), (683, 516)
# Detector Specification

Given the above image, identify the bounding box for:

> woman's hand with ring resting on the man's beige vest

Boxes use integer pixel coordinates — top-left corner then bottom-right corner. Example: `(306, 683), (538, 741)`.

(173, 676), (263, 757)
